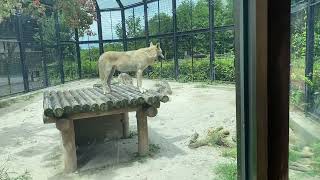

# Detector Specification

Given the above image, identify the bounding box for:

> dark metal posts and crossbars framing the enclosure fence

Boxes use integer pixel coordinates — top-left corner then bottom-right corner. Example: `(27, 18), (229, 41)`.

(1, 0), (320, 124)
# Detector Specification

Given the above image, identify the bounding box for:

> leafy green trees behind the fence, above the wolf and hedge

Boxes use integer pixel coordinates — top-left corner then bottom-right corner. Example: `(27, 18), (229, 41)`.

(116, 0), (234, 59)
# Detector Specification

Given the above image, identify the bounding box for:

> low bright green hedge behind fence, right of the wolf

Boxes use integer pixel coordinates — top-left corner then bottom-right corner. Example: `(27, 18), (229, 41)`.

(150, 56), (235, 82)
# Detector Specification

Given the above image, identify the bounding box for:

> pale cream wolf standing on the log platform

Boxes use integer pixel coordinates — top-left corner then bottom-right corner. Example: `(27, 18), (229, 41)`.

(98, 42), (164, 94)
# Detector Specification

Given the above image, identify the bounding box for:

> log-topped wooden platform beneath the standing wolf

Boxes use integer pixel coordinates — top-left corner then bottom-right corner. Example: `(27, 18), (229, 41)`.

(43, 84), (169, 172)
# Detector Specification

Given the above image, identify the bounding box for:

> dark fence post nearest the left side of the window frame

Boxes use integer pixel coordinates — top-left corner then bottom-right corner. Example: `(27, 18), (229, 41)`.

(209, 0), (216, 80)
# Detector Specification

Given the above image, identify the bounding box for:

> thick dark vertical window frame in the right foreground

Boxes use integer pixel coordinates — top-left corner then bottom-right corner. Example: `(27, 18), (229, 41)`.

(235, 0), (290, 180)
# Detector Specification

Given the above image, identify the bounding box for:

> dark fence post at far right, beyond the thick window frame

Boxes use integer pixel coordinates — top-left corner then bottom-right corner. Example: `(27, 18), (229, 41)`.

(305, 0), (315, 112)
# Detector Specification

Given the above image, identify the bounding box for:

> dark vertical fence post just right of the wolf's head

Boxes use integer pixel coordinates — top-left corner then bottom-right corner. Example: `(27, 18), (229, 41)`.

(172, 0), (179, 79)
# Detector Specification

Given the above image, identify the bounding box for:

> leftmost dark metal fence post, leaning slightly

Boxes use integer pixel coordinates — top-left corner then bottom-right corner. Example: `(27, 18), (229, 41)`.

(16, 11), (30, 92)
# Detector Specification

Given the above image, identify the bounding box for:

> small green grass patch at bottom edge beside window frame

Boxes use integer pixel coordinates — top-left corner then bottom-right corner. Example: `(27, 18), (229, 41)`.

(214, 161), (237, 180)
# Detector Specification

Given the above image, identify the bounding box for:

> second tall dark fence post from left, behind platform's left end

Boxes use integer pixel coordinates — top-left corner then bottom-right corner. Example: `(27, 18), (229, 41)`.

(54, 10), (64, 84)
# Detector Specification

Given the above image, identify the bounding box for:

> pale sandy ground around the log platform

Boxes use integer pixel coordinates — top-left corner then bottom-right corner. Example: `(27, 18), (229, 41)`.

(0, 79), (235, 180)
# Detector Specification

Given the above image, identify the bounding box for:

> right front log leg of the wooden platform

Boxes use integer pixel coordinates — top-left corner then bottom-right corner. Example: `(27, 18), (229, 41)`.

(136, 108), (149, 156)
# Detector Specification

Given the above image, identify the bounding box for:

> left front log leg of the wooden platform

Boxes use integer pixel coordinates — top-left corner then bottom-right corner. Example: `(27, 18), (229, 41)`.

(56, 119), (77, 173)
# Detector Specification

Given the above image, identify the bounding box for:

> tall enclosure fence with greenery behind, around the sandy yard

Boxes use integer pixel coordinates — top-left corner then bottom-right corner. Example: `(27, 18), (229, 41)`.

(0, 0), (320, 119)
